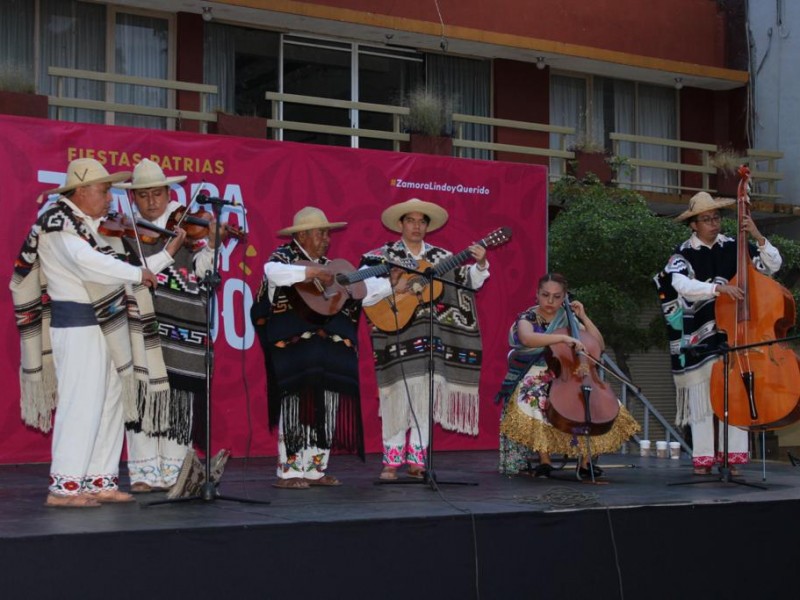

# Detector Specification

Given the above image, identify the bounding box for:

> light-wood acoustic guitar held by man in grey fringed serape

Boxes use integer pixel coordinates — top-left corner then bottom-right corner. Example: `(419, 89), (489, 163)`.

(358, 227), (511, 333)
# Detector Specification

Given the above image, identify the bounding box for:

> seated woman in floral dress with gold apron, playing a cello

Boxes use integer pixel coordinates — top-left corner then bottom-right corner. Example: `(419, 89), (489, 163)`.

(497, 273), (639, 478)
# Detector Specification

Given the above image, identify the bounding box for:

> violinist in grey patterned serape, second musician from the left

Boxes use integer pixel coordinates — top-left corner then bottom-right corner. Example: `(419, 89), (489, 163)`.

(116, 158), (216, 493)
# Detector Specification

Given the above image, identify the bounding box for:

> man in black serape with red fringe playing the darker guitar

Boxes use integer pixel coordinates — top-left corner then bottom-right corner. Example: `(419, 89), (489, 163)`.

(251, 206), (389, 490)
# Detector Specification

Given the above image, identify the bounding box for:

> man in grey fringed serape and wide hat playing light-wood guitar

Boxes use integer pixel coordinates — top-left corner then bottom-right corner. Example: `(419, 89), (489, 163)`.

(361, 198), (489, 480)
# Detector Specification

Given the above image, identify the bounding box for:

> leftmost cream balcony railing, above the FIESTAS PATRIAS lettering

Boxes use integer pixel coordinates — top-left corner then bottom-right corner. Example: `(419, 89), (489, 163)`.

(47, 67), (218, 128)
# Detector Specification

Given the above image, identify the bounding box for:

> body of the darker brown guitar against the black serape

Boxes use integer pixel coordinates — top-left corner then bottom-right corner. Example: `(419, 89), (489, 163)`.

(290, 258), (367, 321)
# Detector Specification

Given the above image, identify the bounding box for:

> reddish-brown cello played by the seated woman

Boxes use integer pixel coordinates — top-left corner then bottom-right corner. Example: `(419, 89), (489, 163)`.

(547, 295), (619, 435)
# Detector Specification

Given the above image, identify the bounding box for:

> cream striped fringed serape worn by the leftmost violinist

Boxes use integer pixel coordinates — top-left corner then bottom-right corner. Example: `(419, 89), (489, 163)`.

(10, 201), (169, 433)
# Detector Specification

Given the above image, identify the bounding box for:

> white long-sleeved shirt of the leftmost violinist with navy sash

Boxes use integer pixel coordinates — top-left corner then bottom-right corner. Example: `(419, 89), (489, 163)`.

(39, 198), (142, 304)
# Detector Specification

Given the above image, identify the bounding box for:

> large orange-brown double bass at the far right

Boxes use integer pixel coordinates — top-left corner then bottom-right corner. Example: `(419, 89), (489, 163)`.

(711, 165), (800, 430)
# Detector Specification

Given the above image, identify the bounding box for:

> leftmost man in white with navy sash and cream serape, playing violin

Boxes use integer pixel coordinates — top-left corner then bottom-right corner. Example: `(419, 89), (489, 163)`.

(11, 158), (167, 508)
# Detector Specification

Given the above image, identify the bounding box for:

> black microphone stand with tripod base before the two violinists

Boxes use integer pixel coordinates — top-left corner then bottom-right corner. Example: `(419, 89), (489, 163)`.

(144, 197), (270, 506)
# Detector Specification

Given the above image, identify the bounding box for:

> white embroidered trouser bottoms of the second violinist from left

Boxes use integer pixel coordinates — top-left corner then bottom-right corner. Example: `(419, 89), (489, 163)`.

(125, 431), (189, 487)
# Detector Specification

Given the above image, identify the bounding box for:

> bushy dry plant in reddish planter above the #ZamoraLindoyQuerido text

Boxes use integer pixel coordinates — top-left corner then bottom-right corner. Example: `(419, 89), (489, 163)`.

(402, 88), (453, 156)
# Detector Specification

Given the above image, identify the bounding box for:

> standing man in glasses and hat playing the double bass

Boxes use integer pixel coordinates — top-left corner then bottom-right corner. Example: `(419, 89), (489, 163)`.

(655, 192), (782, 476)
